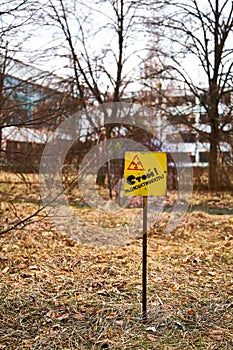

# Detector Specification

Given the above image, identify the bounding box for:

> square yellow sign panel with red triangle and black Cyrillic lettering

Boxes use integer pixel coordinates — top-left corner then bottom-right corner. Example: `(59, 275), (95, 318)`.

(124, 152), (167, 196)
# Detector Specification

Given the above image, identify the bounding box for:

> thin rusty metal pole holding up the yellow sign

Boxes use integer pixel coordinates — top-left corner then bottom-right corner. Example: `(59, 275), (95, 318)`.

(142, 196), (147, 322)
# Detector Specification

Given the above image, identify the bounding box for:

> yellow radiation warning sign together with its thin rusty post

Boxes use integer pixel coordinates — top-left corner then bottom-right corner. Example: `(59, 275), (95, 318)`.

(124, 152), (167, 322)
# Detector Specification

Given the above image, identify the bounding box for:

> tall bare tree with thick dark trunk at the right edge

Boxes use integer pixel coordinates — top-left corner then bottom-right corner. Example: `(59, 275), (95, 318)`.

(149, 0), (233, 191)
